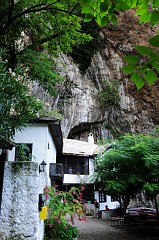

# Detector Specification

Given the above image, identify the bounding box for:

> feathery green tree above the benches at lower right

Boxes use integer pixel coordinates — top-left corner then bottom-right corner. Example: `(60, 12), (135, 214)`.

(96, 134), (159, 213)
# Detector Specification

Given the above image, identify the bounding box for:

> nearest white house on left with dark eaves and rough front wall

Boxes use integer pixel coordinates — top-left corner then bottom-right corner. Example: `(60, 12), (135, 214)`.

(0, 118), (63, 240)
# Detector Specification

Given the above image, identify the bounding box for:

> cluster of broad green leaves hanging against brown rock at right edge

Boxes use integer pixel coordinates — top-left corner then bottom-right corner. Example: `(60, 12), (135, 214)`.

(121, 39), (159, 89)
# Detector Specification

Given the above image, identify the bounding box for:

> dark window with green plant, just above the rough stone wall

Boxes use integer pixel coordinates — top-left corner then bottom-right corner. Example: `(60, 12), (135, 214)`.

(15, 143), (32, 161)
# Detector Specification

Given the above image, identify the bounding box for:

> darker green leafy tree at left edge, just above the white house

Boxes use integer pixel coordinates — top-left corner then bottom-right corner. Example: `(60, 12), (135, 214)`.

(0, 54), (42, 141)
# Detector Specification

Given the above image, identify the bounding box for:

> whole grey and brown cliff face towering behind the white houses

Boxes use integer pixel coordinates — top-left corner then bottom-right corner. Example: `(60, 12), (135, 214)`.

(33, 12), (159, 140)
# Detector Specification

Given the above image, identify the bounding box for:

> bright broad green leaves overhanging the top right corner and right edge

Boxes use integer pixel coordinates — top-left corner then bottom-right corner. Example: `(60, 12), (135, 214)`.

(82, 0), (159, 89)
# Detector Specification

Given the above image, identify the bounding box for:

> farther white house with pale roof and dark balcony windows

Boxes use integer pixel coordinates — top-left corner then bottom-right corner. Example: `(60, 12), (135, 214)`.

(53, 139), (119, 210)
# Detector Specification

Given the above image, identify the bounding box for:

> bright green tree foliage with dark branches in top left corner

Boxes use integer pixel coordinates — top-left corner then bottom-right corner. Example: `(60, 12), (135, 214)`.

(0, 0), (89, 92)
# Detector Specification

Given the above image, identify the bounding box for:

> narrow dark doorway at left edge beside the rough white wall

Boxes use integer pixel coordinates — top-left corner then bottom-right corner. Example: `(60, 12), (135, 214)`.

(0, 150), (6, 213)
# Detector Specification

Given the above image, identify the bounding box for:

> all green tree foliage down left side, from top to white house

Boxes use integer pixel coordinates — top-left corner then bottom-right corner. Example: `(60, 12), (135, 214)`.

(0, 0), (91, 142)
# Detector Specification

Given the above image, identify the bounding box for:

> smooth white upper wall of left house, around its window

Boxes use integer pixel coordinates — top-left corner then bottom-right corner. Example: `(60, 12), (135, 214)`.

(8, 124), (56, 184)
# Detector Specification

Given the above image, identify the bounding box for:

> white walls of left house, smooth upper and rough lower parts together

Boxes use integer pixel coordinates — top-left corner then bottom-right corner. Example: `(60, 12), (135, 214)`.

(0, 124), (57, 240)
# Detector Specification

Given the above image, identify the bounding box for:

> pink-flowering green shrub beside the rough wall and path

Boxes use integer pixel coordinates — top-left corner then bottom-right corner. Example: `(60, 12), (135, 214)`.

(44, 186), (86, 240)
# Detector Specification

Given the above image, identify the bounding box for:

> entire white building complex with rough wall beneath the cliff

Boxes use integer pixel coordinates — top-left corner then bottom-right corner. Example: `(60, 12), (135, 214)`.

(0, 121), (117, 240)
